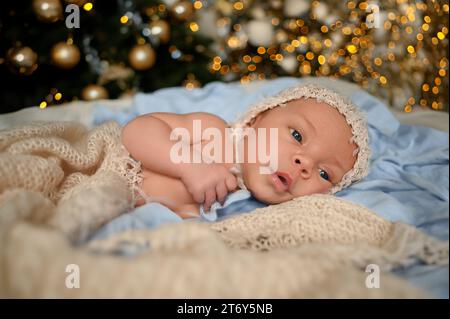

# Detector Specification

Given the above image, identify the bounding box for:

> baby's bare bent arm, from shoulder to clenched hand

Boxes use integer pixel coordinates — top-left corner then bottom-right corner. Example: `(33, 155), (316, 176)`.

(122, 112), (237, 210)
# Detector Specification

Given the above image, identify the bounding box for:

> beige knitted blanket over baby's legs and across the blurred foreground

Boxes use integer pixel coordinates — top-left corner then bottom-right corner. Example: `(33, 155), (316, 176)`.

(0, 122), (448, 298)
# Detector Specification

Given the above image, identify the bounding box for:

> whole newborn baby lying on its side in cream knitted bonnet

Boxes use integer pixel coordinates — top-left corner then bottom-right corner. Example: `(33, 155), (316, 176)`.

(122, 85), (370, 218)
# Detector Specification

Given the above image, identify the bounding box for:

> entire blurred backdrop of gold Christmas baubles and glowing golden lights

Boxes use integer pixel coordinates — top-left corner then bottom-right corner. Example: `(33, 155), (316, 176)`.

(0, 0), (449, 112)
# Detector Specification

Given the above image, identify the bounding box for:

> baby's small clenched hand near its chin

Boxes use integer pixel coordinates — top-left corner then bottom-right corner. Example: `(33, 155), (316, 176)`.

(181, 163), (237, 211)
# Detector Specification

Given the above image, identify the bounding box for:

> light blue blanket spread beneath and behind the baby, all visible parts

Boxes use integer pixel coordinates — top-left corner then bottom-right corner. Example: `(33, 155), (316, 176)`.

(92, 78), (449, 298)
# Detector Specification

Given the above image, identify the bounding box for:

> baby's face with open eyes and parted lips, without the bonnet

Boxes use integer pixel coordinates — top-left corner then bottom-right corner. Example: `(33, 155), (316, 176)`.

(242, 99), (356, 204)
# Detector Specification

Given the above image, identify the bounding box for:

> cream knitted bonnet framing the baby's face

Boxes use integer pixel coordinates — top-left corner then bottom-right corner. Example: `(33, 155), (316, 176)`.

(232, 84), (370, 194)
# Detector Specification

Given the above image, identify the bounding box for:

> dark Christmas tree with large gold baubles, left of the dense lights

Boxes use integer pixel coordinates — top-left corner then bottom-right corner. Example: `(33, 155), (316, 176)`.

(0, 0), (219, 112)
